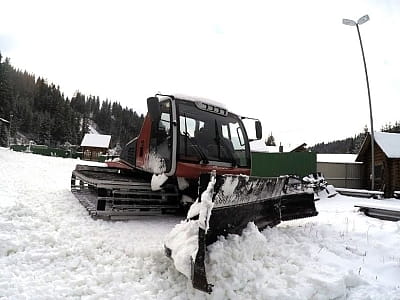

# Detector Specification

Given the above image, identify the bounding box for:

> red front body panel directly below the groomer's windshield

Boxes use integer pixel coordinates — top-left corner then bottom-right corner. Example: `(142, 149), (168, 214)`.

(175, 162), (250, 179)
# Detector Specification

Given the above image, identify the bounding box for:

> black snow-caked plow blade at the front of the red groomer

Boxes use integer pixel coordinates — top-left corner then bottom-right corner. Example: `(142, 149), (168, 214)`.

(165, 175), (318, 293)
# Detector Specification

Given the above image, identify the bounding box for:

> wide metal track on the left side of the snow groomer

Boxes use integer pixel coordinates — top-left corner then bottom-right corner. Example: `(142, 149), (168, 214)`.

(71, 165), (180, 220)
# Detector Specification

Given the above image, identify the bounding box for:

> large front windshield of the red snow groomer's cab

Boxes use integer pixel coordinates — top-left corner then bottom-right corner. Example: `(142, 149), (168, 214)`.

(177, 100), (250, 168)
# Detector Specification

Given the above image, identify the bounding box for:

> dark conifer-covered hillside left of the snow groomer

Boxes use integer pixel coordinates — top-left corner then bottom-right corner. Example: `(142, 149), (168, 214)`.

(0, 53), (143, 147)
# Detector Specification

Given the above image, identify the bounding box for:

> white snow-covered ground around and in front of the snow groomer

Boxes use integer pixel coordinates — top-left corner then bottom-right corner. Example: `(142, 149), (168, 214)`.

(0, 148), (400, 299)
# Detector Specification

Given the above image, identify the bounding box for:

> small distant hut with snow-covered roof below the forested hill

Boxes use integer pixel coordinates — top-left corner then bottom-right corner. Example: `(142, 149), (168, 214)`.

(81, 133), (111, 160)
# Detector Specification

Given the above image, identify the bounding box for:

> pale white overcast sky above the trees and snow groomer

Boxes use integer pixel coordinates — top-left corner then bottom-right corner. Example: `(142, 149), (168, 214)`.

(0, 0), (400, 146)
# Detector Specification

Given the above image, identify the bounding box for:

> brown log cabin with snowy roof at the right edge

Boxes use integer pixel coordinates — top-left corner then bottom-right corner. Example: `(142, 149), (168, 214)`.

(356, 132), (400, 197)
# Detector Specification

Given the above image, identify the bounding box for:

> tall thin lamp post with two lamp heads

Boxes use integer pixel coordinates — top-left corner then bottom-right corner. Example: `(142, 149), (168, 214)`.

(343, 15), (375, 190)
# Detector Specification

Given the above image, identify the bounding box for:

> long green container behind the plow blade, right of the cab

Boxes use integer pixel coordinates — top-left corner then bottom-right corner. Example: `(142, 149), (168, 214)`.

(251, 152), (317, 177)
